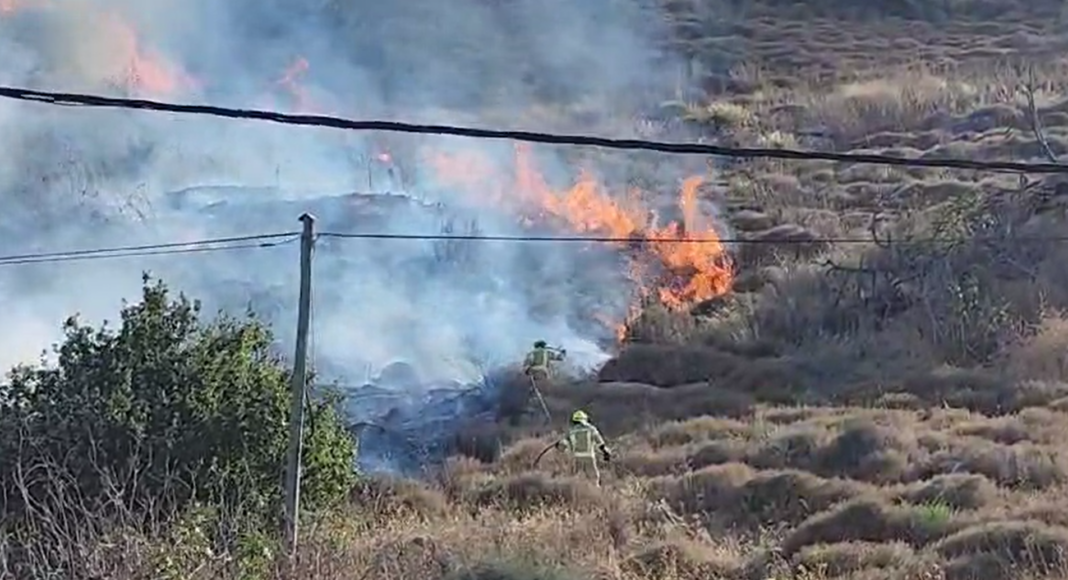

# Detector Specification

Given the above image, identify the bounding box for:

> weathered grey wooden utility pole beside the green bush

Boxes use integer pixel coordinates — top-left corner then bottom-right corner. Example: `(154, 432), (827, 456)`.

(285, 214), (315, 555)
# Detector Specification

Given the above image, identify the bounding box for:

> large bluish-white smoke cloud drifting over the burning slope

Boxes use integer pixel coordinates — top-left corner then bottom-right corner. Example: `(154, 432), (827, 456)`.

(0, 0), (687, 395)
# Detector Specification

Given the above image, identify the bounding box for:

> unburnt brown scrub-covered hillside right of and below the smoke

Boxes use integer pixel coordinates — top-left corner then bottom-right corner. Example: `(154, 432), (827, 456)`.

(10, 0), (1068, 580)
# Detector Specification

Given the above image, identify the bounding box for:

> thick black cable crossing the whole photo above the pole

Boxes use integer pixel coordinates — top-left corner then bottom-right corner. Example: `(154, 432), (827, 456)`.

(0, 87), (1068, 174)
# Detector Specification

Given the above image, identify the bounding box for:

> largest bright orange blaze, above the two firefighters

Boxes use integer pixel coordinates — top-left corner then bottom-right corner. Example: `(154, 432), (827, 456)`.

(429, 144), (734, 340)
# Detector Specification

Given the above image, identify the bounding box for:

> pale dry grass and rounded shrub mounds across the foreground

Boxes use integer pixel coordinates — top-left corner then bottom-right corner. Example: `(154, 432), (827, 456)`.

(22, 397), (1068, 580)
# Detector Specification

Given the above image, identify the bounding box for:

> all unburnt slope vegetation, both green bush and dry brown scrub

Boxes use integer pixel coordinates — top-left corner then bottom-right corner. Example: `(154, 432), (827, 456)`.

(10, 0), (1068, 580)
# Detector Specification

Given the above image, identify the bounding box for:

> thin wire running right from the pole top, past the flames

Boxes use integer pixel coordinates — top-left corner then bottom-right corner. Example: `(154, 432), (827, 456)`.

(319, 232), (1068, 246)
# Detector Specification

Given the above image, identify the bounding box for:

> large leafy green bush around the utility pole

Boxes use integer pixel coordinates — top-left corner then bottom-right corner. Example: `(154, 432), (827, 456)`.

(0, 276), (355, 524)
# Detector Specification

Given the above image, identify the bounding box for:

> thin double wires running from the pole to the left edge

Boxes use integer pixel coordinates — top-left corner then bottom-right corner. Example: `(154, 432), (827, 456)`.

(0, 232), (300, 266)
